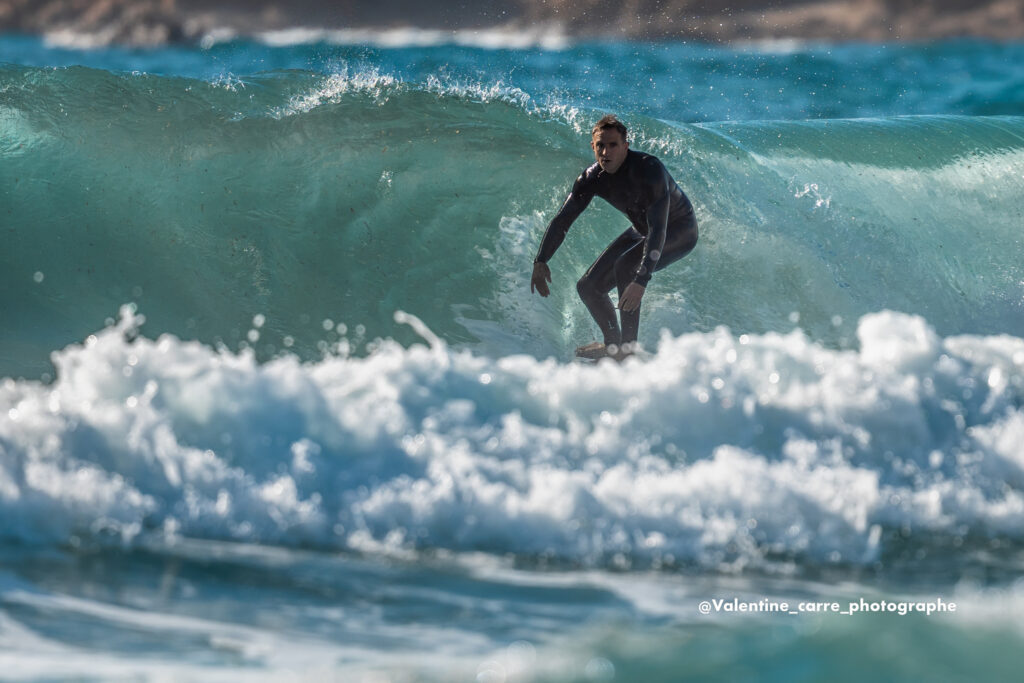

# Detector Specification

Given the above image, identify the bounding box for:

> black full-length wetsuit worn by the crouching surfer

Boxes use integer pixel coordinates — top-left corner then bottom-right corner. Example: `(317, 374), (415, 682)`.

(535, 150), (697, 345)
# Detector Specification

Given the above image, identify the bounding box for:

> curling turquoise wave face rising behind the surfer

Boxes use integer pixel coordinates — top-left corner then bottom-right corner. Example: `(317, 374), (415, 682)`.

(6, 62), (1024, 377)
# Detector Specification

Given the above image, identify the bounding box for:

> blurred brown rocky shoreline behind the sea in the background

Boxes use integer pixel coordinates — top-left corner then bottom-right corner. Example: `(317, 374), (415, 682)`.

(0, 0), (1024, 46)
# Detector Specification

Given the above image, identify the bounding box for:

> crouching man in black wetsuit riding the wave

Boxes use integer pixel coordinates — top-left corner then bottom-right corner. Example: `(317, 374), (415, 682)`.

(529, 115), (697, 359)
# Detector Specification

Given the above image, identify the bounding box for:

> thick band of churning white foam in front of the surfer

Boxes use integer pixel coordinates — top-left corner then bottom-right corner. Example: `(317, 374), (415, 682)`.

(0, 312), (1024, 568)
